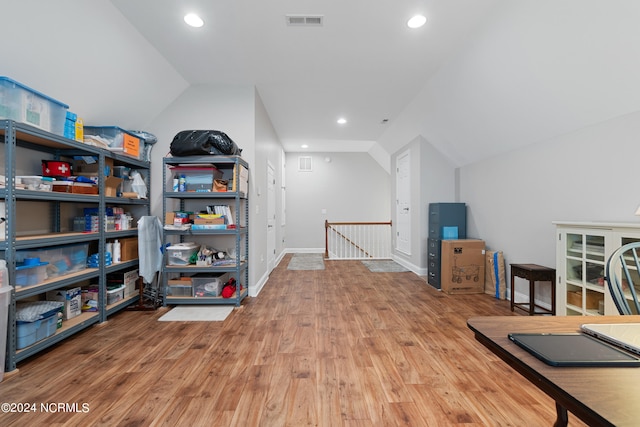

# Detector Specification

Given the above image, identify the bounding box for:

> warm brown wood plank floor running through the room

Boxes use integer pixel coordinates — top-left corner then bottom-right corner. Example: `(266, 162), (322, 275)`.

(0, 256), (583, 427)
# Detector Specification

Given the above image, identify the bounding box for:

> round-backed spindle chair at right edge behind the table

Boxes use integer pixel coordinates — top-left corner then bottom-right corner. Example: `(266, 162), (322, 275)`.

(605, 242), (640, 314)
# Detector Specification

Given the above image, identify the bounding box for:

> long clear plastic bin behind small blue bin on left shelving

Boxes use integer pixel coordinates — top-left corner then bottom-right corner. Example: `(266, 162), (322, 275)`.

(16, 243), (89, 278)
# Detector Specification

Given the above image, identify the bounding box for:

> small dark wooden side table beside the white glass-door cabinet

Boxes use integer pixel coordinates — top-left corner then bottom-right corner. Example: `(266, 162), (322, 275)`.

(510, 264), (556, 316)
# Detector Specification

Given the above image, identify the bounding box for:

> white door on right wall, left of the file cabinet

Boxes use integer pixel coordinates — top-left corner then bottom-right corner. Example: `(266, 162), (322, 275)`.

(396, 150), (411, 255)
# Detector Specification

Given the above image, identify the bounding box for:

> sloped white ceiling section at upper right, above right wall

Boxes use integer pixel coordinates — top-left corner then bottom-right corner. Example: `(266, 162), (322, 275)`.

(378, 0), (640, 170)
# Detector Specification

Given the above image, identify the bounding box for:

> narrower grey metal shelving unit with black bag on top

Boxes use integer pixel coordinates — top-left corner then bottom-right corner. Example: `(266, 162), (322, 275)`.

(162, 156), (249, 306)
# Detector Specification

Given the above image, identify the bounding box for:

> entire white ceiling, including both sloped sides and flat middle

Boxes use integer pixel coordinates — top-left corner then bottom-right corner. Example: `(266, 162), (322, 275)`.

(0, 0), (640, 165)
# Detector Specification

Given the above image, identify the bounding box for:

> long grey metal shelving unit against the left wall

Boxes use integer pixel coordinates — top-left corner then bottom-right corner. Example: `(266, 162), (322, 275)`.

(0, 120), (150, 371)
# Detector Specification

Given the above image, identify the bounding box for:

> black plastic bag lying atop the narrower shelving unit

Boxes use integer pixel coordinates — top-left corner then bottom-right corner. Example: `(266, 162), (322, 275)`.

(170, 130), (242, 157)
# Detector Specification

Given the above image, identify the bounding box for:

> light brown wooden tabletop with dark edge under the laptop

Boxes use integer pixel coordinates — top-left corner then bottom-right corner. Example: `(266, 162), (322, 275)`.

(467, 316), (640, 427)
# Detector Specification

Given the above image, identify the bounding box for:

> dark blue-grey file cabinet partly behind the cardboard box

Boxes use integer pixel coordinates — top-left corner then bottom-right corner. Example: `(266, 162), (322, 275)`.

(427, 203), (467, 289)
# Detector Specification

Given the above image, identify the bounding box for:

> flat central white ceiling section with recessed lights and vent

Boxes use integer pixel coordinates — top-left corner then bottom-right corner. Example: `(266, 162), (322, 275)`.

(111, 0), (497, 151)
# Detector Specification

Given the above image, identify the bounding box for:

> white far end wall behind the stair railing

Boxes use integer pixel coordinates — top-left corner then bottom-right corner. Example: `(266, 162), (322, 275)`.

(285, 153), (390, 252)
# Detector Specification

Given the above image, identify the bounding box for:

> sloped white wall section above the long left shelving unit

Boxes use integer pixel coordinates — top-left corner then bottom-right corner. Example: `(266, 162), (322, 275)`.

(0, 0), (188, 129)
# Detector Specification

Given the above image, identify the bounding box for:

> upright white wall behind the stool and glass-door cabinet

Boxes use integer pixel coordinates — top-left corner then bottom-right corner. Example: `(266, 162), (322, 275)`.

(460, 112), (640, 300)
